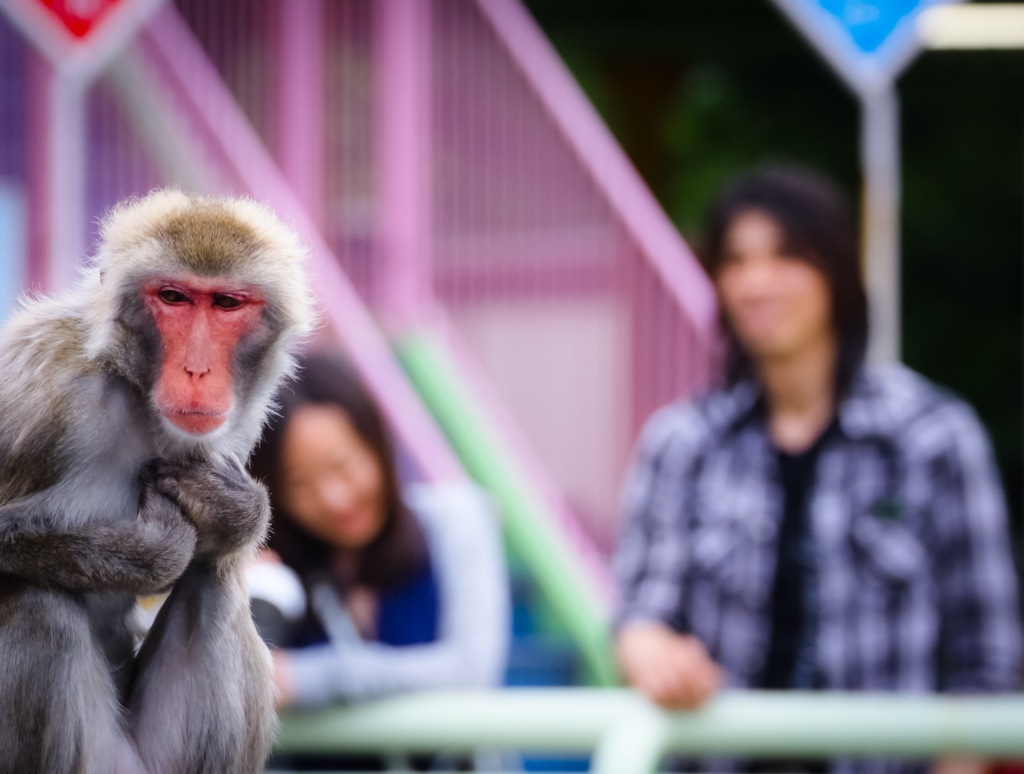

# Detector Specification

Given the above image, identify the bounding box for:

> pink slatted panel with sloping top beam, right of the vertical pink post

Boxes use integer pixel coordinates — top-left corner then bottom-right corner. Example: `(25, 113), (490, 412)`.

(421, 0), (715, 550)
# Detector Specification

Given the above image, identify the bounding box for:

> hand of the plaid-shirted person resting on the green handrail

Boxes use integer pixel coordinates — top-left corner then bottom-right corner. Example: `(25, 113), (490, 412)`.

(615, 620), (723, 710)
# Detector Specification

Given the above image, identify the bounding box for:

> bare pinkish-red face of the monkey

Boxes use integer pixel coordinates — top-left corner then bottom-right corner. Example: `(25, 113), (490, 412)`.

(142, 275), (264, 435)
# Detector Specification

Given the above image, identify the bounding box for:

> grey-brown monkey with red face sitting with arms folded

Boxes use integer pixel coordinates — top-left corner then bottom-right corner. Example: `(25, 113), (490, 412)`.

(0, 189), (316, 774)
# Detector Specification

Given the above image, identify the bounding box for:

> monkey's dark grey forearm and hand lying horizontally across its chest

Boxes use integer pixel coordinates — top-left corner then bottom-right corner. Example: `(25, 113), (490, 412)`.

(0, 470), (196, 594)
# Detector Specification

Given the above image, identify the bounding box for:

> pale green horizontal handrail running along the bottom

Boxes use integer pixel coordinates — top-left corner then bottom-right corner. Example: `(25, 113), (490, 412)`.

(278, 688), (1024, 774)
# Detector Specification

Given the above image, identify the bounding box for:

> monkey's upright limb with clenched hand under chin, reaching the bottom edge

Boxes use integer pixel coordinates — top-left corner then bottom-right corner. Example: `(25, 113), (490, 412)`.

(127, 463), (276, 774)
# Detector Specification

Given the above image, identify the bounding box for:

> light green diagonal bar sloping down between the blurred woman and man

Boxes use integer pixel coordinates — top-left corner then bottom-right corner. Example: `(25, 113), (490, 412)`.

(396, 332), (615, 686)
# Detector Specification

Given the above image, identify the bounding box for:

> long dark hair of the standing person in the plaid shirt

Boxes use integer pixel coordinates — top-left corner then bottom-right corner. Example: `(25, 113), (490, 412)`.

(700, 166), (867, 398)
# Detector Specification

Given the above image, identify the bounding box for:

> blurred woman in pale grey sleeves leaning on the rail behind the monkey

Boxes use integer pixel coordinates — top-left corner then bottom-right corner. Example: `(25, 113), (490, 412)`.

(244, 355), (510, 706)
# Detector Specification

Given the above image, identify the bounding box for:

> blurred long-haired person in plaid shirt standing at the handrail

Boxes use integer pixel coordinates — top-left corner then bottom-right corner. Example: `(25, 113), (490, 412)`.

(615, 167), (1021, 771)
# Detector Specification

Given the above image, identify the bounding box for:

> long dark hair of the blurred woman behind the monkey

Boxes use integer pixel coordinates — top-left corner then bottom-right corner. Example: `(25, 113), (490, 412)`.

(249, 354), (427, 591)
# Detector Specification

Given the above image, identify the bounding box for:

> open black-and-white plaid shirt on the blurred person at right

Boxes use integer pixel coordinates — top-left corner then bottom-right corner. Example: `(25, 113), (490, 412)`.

(615, 366), (1021, 768)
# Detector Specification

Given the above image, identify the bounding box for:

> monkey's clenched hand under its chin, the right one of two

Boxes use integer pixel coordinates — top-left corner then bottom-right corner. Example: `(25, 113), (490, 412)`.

(151, 452), (270, 564)
